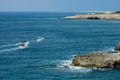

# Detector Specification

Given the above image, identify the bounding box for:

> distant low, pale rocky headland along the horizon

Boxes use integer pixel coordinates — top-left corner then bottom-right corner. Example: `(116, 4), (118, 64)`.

(65, 12), (120, 20)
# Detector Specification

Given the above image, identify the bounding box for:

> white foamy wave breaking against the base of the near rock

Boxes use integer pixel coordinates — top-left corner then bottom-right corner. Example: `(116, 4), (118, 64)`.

(56, 57), (111, 73)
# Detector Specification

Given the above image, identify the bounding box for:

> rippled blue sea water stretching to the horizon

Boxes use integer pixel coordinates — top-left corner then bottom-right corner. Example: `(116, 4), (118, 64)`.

(0, 12), (120, 80)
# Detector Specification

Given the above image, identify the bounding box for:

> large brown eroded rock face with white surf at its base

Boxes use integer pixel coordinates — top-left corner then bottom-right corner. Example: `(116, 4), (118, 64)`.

(71, 52), (120, 68)
